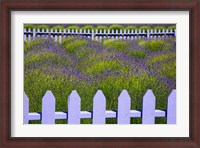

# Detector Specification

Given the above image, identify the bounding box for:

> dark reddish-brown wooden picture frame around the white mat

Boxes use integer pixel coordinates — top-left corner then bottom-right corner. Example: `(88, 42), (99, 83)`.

(0, 0), (200, 148)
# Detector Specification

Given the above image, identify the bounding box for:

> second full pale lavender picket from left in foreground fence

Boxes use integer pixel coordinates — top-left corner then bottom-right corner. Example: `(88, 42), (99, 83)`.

(68, 90), (81, 124)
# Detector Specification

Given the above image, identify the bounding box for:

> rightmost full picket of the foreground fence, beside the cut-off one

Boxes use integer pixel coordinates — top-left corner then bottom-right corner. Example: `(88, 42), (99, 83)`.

(142, 90), (156, 124)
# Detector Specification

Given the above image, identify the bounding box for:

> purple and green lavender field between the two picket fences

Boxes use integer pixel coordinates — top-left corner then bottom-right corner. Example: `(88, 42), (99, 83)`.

(24, 26), (176, 124)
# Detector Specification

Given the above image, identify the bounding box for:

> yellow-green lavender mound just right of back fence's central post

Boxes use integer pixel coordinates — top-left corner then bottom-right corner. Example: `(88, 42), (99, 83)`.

(103, 39), (128, 53)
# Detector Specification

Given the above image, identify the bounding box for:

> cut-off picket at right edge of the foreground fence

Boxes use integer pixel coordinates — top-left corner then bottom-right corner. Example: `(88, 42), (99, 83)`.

(167, 90), (176, 124)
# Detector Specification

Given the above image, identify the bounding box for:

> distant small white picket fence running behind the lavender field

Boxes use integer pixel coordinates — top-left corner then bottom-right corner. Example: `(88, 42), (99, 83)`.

(24, 28), (176, 43)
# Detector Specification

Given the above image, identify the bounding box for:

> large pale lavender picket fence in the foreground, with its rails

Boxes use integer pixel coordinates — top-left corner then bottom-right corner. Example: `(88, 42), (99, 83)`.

(24, 90), (176, 124)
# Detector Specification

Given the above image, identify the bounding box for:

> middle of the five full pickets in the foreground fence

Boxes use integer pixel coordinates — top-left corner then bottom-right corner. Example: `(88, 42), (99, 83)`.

(92, 90), (106, 124)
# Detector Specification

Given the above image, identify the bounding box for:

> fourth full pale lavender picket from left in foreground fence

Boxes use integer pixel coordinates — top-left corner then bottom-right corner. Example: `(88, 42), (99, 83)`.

(117, 90), (131, 124)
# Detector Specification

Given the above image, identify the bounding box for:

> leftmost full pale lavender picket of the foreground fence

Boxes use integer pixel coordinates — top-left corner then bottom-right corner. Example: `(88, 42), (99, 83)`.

(42, 91), (56, 124)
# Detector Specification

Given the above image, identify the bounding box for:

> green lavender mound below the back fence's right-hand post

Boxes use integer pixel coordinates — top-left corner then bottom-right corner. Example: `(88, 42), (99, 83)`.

(145, 39), (172, 51)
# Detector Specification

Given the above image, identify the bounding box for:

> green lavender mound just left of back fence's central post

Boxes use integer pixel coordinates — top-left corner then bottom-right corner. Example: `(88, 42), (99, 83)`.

(65, 40), (89, 53)
